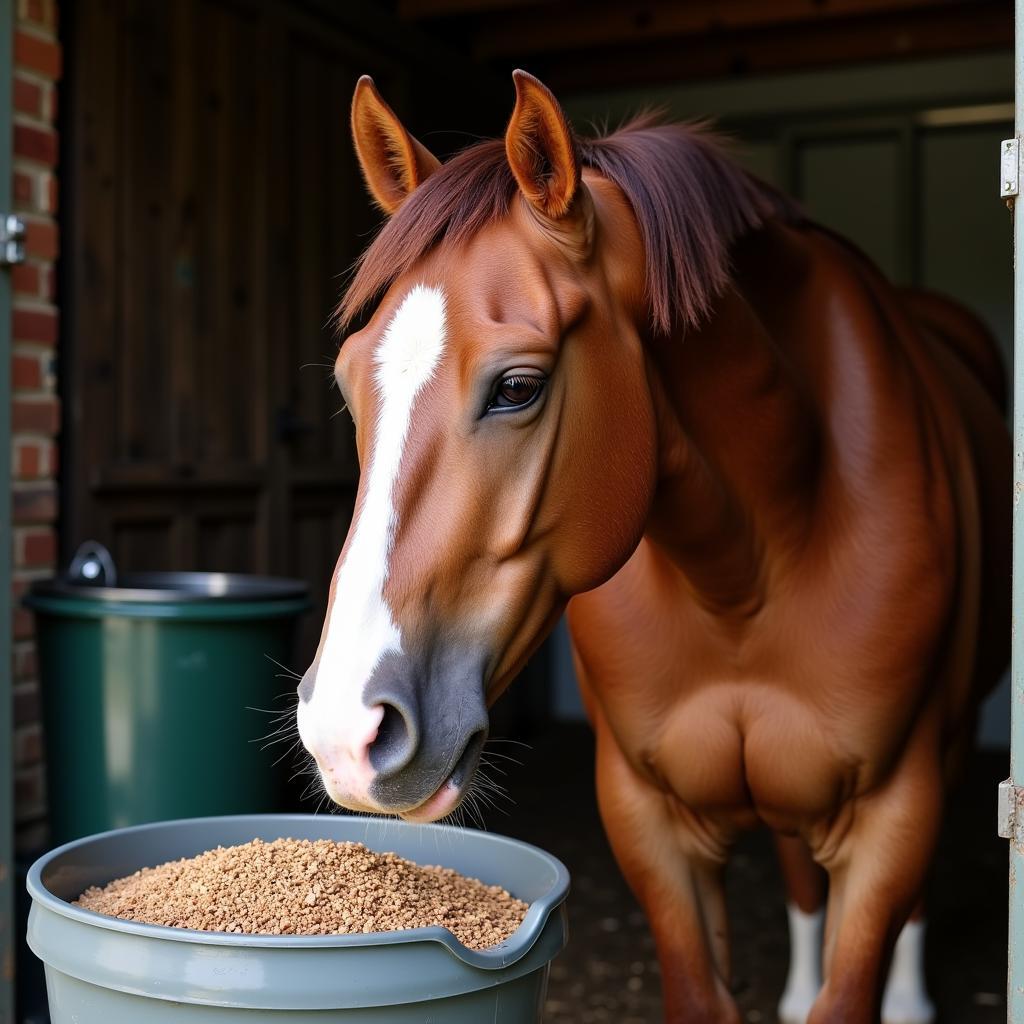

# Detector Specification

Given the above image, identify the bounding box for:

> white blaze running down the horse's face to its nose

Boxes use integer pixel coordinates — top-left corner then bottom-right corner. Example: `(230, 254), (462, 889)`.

(298, 285), (444, 797)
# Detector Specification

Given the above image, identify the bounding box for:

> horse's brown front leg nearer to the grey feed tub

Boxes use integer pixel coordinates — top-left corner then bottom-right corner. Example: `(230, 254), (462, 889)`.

(595, 723), (740, 1024)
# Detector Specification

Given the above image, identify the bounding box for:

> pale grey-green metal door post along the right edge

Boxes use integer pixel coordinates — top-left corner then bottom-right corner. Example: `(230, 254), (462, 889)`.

(1000, 6), (1024, 1024)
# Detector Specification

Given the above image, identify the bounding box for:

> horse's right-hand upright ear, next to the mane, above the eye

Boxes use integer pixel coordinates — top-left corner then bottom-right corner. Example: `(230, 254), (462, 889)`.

(505, 71), (580, 220)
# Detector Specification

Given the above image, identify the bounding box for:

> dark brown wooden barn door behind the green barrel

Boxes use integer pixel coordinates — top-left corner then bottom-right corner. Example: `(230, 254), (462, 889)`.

(61, 0), (406, 655)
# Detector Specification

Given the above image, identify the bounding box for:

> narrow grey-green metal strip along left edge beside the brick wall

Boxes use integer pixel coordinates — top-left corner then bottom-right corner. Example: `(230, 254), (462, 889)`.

(0, 0), (14, 1024)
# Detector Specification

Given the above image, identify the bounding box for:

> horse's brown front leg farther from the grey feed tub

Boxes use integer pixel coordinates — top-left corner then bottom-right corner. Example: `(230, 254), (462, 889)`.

(808, 744), (943, 1024)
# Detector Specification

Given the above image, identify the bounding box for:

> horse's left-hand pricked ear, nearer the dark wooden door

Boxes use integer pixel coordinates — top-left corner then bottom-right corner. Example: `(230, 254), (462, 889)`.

(352, 75), (441, 216)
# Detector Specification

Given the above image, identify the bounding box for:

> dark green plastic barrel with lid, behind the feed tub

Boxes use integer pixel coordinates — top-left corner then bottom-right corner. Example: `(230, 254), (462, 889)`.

(26, 563), (309, 843)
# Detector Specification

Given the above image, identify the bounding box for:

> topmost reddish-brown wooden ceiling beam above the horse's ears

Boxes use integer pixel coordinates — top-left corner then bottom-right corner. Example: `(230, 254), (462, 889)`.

(473, 0), (983, 59)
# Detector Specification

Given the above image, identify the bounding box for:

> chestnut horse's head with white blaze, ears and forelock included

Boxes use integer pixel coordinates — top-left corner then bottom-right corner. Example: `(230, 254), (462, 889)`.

(297, 72), (656, 820)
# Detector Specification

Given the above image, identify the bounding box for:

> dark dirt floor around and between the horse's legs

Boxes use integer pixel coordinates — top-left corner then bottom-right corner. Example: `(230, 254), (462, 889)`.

(486, 726), (1008, 1024)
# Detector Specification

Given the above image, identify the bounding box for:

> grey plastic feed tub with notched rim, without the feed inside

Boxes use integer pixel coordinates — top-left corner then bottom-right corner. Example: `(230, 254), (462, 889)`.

(29, 814), (569, 1024)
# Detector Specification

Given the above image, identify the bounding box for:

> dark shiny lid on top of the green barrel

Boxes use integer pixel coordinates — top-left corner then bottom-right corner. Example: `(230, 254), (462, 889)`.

(30, 572), (309, 604)
